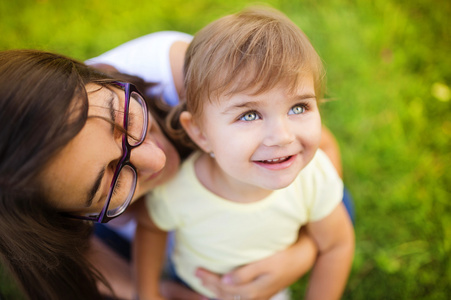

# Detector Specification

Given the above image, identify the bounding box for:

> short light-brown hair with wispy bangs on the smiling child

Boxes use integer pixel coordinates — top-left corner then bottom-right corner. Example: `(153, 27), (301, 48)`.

(184, 7), (324, 116)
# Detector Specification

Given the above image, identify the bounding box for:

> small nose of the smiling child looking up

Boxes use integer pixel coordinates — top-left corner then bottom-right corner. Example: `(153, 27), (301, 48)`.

(263, 120), (295, 147)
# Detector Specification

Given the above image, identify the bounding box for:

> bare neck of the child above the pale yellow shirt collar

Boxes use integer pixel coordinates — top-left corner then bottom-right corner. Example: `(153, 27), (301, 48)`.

(194, 153), (273, 203)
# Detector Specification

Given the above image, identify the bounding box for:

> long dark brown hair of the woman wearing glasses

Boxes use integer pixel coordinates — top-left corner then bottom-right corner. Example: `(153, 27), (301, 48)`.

(0, 50), (119, 300)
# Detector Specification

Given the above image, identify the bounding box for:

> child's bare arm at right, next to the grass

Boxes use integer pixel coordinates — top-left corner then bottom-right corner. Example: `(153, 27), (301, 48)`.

(306, 203), (354, 299)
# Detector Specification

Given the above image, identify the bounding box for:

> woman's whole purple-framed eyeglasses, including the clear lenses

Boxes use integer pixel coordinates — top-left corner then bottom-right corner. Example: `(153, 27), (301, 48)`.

(70, 81), (149, 223)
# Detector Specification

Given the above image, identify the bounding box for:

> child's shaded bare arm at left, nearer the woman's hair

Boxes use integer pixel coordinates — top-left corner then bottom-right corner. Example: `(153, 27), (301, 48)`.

(133, 201), (167, 300)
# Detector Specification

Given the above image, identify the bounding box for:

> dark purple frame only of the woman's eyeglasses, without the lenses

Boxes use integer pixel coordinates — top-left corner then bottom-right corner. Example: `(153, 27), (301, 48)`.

(66, 81), (149, 223)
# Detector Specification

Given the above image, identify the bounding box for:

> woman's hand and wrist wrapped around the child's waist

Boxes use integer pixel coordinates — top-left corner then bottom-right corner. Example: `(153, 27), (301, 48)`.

(196, 230), (317, 300)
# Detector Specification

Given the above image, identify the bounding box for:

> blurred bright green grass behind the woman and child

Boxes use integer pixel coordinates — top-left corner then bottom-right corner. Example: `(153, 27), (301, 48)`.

(0, 0), (451, 299)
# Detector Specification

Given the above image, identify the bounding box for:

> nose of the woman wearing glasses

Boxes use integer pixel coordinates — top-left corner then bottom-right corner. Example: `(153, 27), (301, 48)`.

(130, 139), (166, 174)
